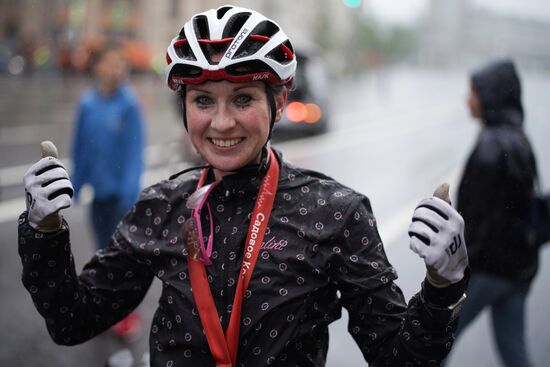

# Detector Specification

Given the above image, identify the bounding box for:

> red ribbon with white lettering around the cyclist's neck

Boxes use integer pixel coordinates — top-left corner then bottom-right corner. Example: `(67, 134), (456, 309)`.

(187, 149), (279, 367)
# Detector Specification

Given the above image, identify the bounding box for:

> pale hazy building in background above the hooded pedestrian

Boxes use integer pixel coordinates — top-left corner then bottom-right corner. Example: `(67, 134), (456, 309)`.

(420, 0), (550, 70)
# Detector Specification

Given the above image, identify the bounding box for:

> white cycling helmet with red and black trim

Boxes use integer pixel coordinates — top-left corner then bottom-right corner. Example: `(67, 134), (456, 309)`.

(165, 5), (296, 90)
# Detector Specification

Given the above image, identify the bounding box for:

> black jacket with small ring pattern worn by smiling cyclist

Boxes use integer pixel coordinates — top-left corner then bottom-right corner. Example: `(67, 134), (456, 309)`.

(19, 151), (466, 367)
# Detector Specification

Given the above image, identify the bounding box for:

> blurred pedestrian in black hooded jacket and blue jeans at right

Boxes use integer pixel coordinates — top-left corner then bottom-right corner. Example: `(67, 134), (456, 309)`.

(450, 60), (538, 367)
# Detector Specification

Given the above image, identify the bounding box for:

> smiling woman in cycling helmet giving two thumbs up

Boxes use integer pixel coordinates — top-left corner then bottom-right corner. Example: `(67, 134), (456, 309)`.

(20, 6), (467, 366)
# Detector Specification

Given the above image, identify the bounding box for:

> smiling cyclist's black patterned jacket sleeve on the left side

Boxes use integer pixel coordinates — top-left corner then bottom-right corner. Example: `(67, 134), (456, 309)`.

(19, 212), (153, 345)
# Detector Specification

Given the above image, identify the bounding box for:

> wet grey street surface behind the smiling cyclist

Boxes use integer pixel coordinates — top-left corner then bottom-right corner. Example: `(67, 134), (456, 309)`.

(0, 69), (550, 367)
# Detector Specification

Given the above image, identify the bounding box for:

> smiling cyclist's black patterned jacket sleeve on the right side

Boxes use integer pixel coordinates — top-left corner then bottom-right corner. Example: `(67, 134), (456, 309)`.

(330, 198), (466, 367)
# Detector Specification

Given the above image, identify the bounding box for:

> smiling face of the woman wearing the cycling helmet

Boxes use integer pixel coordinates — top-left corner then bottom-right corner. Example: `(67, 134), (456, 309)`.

(185, 80), (286, 179)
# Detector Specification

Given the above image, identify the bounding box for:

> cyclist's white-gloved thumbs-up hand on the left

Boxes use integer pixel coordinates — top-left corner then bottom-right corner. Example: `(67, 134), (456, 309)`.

(23, 141), (74, 232)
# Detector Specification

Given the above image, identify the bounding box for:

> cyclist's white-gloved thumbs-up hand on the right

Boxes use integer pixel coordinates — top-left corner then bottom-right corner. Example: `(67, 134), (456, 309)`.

(409, 183), (468, 288)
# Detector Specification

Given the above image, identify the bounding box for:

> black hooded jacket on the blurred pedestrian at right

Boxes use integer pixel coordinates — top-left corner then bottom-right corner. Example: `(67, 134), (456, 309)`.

(458, 61), (537, 281)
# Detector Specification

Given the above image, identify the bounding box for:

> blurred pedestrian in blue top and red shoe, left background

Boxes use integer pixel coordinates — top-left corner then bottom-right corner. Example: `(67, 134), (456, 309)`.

(71, 43), (145, 337)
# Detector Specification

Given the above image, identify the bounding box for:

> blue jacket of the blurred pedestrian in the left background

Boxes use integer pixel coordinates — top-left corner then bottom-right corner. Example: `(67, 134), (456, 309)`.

(71, 85), (144, 208)
